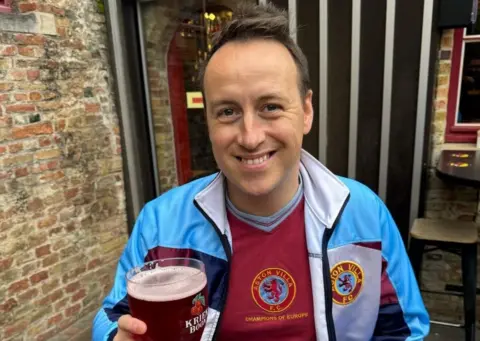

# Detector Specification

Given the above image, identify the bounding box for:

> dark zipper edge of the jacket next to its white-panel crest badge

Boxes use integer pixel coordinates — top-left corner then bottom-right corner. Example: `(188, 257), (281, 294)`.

(322, 194), (350, 341)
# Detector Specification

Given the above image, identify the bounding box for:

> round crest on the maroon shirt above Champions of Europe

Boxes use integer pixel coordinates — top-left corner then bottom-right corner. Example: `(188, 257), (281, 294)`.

(252, 268), (297, 313)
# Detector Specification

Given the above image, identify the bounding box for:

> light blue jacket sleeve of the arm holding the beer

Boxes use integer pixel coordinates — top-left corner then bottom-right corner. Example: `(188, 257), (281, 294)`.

(92, 208), (153, 341)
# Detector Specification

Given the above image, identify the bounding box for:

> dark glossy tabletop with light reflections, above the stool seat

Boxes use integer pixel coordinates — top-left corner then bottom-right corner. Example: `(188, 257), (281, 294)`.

(437, 150), (480, 188)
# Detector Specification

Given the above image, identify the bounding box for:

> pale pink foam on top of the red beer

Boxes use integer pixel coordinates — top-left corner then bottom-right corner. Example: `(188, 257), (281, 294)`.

(127, 266), (207, 302)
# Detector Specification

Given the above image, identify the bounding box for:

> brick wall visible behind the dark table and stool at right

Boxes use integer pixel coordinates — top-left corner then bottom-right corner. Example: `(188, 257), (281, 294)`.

(422, 30), (480, 322)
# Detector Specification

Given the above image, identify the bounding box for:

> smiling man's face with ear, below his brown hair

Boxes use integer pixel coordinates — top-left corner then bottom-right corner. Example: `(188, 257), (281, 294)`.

(204, 40), (313, 196)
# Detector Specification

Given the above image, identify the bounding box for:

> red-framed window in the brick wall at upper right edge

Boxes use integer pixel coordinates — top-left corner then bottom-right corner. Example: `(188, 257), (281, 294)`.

(445, 22), (480, 143)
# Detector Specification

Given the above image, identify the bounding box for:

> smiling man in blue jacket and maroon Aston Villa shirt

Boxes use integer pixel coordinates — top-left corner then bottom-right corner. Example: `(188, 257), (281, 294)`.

(93, 5), (429, 341)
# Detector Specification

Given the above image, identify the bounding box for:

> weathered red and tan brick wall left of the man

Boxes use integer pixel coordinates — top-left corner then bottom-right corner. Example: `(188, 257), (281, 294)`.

(0, 0), (127, 341)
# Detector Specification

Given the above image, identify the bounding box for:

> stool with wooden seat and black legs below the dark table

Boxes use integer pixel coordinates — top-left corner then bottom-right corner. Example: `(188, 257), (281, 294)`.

(408, 218), (478, 341)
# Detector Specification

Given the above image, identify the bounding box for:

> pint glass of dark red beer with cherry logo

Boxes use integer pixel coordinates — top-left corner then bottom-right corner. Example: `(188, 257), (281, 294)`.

(126, 258), (208, 341)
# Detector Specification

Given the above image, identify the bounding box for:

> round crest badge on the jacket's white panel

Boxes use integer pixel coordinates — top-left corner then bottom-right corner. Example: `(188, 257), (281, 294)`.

(330, 261), (364, 305)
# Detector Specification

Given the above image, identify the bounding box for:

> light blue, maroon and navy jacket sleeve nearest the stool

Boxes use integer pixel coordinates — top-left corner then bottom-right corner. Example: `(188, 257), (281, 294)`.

(372, 199), (430, 341)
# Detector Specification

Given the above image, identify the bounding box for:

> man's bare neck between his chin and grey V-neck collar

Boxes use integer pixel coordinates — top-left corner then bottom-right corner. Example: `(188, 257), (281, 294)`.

(227, 175), (299, 217)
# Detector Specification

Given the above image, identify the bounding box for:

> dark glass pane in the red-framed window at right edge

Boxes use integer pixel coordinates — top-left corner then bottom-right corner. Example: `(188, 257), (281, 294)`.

(457, 42), (480, 123)
